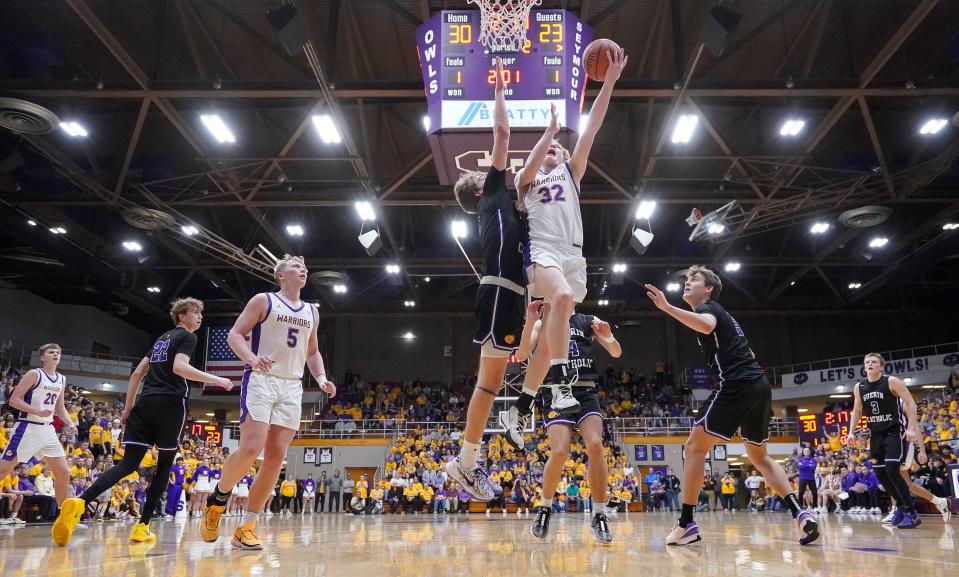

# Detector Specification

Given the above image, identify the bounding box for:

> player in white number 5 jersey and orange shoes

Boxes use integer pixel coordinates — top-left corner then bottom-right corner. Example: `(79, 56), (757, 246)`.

(200, 255), (336, 550)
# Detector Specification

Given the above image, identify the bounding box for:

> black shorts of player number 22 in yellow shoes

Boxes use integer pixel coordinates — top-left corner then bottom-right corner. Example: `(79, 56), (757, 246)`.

(123, 395), (186, 451)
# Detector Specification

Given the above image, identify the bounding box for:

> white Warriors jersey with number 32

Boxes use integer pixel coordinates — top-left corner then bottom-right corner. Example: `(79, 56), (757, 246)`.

(516, 162), (583, 248)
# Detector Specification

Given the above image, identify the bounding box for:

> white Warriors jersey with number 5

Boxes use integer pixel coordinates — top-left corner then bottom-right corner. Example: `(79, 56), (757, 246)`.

(250, 293), (319, 379)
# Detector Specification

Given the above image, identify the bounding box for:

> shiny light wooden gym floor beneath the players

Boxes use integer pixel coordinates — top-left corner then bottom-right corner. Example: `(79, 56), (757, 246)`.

(0, 512), (959, 577)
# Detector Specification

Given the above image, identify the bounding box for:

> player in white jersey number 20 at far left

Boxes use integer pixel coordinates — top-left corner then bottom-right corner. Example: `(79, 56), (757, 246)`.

(0, 343), (76, 521)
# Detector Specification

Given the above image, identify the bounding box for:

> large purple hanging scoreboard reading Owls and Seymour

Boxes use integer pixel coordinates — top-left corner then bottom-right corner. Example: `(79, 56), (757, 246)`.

(416, 10), (592, 184)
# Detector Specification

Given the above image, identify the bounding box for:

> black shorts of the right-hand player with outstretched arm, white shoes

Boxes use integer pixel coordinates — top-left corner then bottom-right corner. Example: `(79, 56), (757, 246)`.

(696, 376), (773, 445)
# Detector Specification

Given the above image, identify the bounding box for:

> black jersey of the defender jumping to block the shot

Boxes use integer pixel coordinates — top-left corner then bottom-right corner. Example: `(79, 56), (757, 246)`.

(479, 168), (528, 287)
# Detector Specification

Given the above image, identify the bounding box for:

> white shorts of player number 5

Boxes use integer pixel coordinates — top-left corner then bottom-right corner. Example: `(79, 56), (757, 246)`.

(240, 372), (303, 431)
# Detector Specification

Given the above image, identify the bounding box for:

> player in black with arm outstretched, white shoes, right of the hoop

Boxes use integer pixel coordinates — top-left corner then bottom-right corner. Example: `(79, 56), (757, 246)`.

(646, 266), (819, 545)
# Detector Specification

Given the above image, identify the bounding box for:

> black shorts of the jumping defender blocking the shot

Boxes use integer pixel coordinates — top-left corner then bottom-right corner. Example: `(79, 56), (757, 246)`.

(473, 284), (526, 358)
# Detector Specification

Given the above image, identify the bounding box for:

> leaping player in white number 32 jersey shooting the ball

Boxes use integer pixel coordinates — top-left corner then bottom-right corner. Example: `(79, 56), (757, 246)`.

(507, 50), (628, 428)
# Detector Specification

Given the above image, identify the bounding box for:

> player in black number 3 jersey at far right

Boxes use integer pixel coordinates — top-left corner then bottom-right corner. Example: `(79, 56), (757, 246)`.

(846, 353), (921, 529)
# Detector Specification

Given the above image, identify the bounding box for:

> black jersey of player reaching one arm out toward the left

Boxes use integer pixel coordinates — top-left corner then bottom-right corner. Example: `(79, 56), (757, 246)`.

(696, 300), (763, 386)
